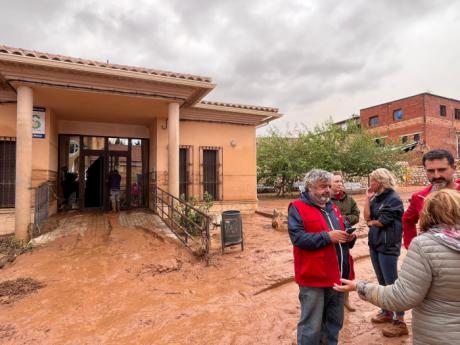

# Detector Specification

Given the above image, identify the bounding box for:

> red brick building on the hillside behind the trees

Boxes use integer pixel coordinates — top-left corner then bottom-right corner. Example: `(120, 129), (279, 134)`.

(360, 92), (460, 158)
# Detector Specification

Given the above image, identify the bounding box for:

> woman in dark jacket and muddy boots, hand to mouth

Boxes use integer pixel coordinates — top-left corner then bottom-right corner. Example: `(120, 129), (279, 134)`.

(364, 168), (409, 337)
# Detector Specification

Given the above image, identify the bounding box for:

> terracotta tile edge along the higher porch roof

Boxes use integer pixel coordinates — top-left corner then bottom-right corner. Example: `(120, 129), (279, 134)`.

(0, 45), (212, 83)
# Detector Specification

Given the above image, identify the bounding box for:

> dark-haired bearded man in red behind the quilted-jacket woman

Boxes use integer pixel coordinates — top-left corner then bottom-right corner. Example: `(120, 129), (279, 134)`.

(402, 150), (460, 249)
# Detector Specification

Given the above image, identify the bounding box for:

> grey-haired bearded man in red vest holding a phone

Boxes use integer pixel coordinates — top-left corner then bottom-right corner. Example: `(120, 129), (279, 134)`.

(288, 169), (356, 345)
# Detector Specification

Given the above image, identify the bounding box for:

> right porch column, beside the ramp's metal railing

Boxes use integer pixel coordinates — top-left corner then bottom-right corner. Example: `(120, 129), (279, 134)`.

(168, 103), (179, 197)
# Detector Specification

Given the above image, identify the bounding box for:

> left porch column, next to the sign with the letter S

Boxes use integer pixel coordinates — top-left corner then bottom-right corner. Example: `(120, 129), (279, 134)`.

(15, 86), (33, 240)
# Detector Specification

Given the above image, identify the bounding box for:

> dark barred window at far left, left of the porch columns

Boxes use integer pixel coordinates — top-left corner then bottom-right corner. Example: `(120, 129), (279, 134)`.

(0, 137), (16, 208)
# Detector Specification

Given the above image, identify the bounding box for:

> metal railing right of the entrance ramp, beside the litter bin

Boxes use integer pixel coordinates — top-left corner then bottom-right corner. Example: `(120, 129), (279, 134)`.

(151, 171), (211, 256)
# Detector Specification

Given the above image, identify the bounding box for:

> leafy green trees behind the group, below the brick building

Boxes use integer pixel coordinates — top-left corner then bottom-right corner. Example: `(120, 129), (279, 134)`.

(257, 122), (404, 195)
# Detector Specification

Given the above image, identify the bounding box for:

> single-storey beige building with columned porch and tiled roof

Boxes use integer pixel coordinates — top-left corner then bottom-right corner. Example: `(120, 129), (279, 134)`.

(0, 45), (280, 238)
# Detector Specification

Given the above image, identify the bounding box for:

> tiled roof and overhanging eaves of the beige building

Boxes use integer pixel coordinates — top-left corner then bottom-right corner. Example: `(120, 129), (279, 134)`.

(0, 45), (282, 126)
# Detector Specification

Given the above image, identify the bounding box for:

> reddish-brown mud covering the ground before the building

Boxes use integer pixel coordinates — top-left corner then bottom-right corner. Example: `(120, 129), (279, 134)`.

(0, 189), (420, 345)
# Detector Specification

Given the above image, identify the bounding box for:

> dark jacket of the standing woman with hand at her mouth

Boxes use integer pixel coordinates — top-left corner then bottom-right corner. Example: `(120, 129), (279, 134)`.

(369, 188), (404, 256)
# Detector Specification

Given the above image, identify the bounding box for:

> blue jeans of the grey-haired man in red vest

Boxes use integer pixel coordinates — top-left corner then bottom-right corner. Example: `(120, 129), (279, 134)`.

(297, 286), (344, 345)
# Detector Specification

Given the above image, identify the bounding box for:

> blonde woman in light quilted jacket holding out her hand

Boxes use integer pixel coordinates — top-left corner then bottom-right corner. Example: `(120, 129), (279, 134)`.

(334, 189), (460, 345)
